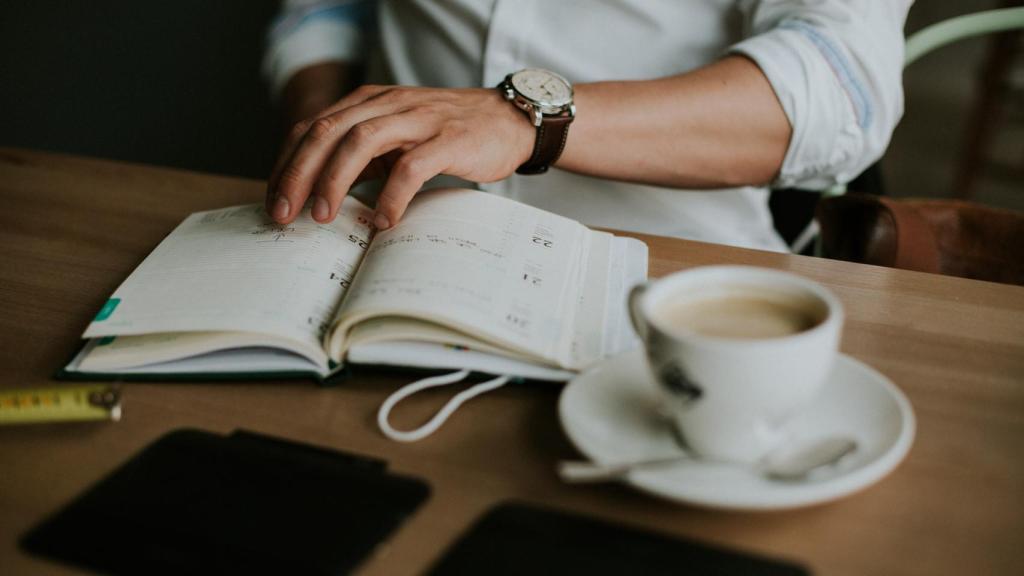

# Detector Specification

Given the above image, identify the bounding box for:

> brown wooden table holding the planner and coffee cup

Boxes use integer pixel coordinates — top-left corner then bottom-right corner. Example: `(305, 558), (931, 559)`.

(0, 150), (1024, 575)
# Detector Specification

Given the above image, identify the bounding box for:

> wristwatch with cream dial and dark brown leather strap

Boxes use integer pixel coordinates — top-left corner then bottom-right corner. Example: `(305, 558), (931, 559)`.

(498, 68), (575, 174)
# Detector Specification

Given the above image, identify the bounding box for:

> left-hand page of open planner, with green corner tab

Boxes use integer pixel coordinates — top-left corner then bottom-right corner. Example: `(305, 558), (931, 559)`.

(85, 198), (373, 346)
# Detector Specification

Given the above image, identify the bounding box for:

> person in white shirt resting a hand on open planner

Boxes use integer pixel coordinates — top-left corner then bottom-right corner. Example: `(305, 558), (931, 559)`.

(264, 0), (911, 251)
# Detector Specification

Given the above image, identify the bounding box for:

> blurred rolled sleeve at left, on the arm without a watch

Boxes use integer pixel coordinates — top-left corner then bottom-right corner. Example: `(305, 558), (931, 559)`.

(263, 0), (375, 97)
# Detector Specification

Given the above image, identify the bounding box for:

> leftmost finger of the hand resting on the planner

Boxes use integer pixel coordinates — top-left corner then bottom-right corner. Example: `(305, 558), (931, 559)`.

(266, 86), (390, 223)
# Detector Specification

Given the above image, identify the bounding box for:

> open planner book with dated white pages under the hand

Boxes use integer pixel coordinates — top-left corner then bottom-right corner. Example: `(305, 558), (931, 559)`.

(65, 189), (647, 380)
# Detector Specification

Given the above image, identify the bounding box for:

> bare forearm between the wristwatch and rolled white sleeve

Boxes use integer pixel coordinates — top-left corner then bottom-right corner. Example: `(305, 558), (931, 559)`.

(556, 56), (792, 189)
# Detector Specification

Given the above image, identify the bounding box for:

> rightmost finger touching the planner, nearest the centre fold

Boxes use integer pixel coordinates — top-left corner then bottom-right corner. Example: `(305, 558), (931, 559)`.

(374, 136), (453, 230)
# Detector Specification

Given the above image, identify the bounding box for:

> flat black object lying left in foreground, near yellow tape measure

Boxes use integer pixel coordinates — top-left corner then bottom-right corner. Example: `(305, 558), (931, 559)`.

(22, 429), (429, 575)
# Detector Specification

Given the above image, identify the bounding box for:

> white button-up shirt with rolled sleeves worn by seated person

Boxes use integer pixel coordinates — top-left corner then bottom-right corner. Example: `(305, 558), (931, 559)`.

(264, 0), (911, 250)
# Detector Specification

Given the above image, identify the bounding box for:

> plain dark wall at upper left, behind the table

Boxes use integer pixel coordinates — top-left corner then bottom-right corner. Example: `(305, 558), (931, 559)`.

(0, 0), (276, 177)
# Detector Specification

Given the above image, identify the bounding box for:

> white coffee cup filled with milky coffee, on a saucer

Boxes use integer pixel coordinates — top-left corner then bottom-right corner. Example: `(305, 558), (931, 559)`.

(630, 265), (843, 462)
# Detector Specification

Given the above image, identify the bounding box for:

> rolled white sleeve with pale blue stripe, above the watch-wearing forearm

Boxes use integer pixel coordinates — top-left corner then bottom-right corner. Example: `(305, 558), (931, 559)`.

(730, 0), (911, 189)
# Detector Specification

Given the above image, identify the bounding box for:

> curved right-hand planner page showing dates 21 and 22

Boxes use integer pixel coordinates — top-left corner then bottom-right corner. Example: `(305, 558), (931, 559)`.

(329, 189), (590, 365)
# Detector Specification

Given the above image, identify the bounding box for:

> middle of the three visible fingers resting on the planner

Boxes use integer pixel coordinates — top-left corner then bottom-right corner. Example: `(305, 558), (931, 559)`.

(312, 112), (435, 222)
